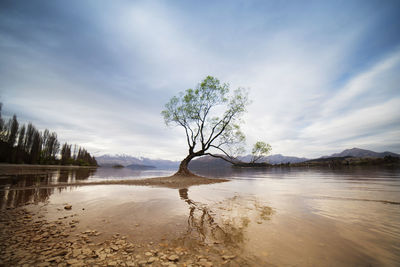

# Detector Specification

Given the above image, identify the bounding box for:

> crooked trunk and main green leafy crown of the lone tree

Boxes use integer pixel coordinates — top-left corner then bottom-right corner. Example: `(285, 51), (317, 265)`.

(161, 76), (249, 176)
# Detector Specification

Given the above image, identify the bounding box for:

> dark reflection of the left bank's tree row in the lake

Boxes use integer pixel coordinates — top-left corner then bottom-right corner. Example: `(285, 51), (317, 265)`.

(0, 168), (96, 209)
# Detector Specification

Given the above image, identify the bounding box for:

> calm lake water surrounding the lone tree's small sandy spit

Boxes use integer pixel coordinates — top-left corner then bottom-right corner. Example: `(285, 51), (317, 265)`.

(0, 168), (400, 266)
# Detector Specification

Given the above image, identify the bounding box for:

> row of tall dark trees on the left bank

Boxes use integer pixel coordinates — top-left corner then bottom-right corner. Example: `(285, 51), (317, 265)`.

(0, 103), (97, 166)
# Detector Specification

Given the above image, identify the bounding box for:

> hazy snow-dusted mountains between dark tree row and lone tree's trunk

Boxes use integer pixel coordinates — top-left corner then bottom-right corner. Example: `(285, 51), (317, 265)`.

(96, 154), (179, 169)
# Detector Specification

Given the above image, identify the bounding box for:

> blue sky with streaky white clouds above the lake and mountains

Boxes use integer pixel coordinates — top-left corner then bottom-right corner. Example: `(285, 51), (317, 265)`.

(0, 0), (400, 160)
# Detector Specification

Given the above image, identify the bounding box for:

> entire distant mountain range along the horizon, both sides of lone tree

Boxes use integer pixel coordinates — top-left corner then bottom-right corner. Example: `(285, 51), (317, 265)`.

(96, 148), (400, 170)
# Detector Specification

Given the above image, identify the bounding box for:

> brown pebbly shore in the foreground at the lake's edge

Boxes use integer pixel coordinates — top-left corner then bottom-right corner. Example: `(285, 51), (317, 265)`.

(0, 204), (247, 267)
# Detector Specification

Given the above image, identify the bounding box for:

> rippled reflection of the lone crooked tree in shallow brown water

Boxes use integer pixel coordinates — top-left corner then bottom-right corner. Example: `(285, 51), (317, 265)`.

(179, 188), (273, 249)
